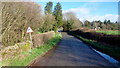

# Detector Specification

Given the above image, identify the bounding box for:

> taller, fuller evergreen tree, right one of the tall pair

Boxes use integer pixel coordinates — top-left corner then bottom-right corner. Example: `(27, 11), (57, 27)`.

(53, 2), (63, 29)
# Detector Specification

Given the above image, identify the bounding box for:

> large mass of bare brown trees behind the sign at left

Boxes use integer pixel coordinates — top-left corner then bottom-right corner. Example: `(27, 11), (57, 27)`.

(1, 2), (43, 46)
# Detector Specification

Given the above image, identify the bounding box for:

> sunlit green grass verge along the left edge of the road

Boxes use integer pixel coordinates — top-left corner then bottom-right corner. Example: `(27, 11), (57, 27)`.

(2, 33), (62, 68)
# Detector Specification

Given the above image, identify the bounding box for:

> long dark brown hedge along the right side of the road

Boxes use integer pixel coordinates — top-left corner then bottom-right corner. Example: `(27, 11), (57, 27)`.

(71, 30), (120, 47)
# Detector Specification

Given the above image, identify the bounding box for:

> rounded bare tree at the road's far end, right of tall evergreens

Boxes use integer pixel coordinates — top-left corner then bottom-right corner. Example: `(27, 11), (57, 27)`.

(63, 12), (82, 30)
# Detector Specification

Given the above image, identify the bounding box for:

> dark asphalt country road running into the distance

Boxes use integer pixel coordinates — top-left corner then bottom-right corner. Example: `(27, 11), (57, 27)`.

(31, 32), (113, 66)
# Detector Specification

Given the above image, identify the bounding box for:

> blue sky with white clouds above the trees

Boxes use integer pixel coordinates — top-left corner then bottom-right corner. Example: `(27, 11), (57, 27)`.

(37, 0), (118, 22)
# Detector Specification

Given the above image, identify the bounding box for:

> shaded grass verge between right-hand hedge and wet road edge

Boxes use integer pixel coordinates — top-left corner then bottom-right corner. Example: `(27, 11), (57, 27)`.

(70, 33), (120, 62)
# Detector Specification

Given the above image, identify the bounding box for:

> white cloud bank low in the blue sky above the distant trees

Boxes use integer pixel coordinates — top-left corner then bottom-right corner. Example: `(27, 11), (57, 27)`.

(63, 7), (118, 22)
